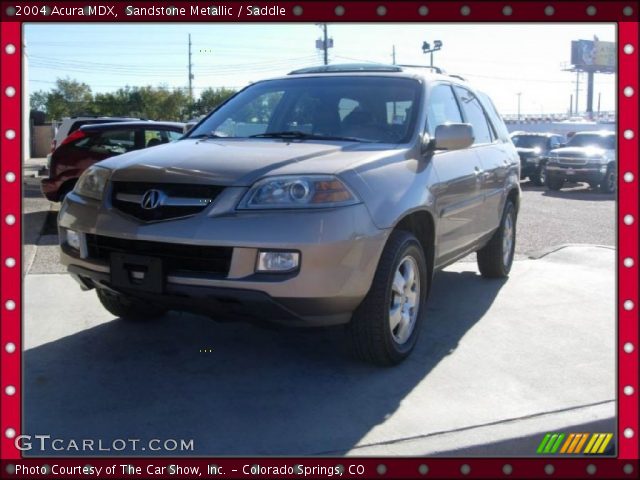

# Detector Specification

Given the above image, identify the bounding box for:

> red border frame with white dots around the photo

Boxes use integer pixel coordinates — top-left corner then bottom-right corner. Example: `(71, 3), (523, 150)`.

(0, 0), (640, 478)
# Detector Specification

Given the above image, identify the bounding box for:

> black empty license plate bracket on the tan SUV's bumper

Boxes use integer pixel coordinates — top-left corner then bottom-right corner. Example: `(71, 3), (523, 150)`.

(110, 252), (164, 294)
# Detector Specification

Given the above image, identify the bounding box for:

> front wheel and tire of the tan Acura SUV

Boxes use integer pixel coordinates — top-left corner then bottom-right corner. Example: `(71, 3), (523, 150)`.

(349, 230), (428, 366)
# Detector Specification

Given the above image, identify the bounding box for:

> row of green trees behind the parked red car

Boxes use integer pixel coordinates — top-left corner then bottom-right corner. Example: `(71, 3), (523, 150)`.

(30, 79), (236, 121)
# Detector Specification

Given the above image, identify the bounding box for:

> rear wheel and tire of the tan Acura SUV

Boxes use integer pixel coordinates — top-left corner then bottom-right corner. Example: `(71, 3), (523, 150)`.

(477, 200), (517, 278)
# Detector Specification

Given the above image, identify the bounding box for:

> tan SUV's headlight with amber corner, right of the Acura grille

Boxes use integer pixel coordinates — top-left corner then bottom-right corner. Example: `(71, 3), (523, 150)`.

(238, 175), (360, 209)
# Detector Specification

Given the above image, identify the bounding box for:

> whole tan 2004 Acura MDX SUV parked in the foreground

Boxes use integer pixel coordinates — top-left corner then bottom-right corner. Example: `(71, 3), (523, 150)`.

(59, 65), (520, 364)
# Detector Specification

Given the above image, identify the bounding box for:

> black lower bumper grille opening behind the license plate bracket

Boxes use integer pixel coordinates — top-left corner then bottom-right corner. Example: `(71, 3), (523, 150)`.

(86, 234), (233, 276)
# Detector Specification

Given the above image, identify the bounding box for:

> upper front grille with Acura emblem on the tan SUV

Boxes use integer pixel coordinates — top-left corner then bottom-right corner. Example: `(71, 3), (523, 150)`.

(111, 182), (224, 222)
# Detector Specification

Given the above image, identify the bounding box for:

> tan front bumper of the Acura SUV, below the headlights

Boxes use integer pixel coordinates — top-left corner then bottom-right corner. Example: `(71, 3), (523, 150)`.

(59, 188), (389, 326)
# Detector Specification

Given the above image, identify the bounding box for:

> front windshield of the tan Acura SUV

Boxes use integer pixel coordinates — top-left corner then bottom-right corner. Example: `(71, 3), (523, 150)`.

(187, 76), (421, 143)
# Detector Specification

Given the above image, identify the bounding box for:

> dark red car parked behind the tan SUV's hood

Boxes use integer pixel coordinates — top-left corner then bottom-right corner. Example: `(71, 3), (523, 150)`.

(40, 121), (185, 202)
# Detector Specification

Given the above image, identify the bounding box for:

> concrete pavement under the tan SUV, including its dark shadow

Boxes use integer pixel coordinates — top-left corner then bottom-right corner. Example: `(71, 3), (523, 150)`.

(23, 246), (616, 456)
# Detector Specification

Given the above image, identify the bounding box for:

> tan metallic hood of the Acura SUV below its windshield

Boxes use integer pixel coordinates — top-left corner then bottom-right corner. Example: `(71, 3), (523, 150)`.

(99, 139), (389, 187)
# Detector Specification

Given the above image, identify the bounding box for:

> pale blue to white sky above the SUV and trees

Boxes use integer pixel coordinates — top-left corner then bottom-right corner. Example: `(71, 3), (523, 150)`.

(23, 23), (616, 115)
